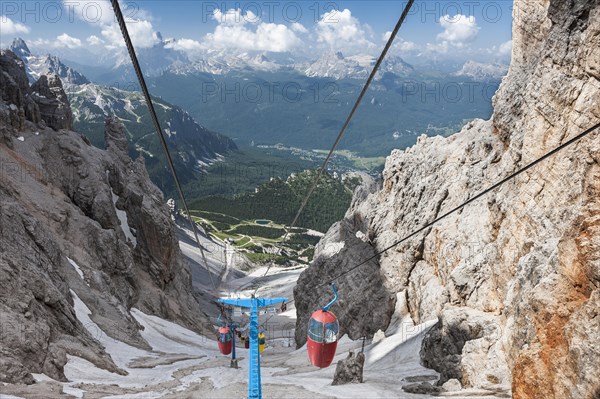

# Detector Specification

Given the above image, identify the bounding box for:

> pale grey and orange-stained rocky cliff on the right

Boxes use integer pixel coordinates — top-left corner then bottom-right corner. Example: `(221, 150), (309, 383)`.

(294, 0), (600, 399)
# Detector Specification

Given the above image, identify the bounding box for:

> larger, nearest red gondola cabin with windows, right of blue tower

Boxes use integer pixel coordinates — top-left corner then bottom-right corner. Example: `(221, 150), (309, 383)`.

(307, 310), (340, 368)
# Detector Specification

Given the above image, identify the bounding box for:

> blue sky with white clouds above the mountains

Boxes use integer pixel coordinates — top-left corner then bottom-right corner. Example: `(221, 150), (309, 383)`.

(0, 0), (512, 60)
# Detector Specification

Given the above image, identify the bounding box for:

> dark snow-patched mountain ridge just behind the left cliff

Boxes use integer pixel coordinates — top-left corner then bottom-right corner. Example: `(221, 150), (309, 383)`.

(9, 39), (237, 194)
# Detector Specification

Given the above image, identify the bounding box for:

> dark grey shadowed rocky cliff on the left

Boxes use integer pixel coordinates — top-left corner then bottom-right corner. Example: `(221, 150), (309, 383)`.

(0, 51), (210, 383)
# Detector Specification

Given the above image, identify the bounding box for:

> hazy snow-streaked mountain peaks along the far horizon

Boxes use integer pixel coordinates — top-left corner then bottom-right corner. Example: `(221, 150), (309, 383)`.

(22, 33), (507, 84)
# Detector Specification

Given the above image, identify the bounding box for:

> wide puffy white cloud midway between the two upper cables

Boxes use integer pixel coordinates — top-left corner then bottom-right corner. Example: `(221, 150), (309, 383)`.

(204, 9), (301, 52)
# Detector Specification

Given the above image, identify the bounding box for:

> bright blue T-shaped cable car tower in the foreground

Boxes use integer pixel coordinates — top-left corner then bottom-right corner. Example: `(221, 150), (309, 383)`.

(218, 295), (287, 399)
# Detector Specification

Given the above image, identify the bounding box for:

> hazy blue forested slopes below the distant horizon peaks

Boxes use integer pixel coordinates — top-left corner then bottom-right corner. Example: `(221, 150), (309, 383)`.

(152, 71), (500, 157)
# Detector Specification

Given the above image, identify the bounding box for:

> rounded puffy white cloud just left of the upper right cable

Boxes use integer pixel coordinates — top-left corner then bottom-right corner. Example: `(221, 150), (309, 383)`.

(316, 9), (375, 53)
